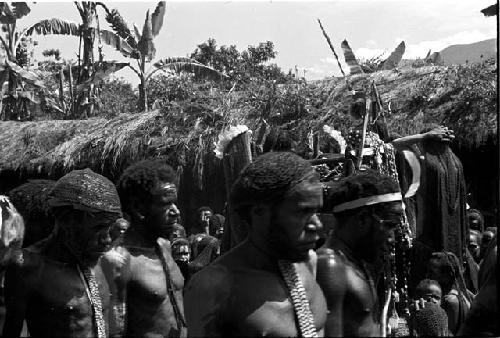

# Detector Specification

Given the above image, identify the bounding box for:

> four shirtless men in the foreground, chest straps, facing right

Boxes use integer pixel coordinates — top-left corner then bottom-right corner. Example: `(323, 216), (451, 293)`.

(3, 152), (494, 337)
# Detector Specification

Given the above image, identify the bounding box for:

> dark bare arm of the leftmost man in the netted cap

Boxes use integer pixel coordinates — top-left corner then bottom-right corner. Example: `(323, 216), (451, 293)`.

(3, 264), (30, 337)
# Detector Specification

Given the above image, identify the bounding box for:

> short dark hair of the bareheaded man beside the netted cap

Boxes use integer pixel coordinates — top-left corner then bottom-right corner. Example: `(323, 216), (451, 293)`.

(117, 159), (177, 210)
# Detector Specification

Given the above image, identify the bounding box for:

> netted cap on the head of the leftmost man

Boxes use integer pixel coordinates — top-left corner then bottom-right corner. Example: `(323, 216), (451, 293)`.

(49, 169), (122, 216)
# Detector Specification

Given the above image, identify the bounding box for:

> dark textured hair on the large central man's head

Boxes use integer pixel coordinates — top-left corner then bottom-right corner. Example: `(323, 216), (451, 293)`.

(230, 152), (318, 221)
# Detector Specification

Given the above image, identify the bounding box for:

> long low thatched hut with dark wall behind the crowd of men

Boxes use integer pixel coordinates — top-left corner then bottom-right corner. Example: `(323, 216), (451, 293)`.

(0, 61), (498, 224)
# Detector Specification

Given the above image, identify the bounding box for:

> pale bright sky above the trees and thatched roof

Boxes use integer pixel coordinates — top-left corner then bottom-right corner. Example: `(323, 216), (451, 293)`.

(18, 0), (498, 86)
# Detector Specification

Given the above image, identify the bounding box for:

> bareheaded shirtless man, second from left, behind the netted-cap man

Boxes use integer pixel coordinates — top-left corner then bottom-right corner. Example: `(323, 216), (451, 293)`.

(103, 159), (185, 337)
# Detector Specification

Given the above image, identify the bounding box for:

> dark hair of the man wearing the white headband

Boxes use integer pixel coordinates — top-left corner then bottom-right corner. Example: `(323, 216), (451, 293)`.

(323, 170), (400, 218)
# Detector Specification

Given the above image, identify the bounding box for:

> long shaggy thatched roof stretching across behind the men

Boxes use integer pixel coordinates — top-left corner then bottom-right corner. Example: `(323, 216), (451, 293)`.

(0, 65), (498, 178)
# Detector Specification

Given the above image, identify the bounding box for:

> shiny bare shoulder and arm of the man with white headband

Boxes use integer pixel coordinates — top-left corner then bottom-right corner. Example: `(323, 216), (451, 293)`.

(316, 253), (347, 337)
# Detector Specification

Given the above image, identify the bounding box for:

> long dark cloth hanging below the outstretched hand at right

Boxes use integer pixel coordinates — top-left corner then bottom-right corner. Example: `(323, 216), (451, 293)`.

(416, 142), (468, 262)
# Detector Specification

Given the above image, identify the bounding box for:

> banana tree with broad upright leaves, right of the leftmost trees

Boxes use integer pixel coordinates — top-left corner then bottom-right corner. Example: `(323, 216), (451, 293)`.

(101, 1), (224, 111)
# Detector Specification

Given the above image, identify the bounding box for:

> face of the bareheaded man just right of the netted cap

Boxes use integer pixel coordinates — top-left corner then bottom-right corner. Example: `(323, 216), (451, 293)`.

(145, 182), (180, 238)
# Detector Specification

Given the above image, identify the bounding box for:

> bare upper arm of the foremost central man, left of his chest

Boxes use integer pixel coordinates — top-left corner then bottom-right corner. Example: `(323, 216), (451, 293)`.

(184, 266), (231, 337)
